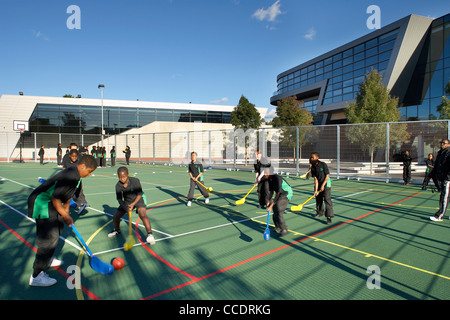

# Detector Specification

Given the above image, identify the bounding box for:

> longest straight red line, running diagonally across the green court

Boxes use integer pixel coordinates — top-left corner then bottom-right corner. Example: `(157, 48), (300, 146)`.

(142, 192), (421, 300)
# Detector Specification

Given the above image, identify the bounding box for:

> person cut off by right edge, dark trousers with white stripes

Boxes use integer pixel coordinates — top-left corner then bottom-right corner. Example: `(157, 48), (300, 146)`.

(430, 139), (450, 221)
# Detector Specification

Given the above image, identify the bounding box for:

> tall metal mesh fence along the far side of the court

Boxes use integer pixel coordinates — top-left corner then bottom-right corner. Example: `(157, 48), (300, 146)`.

(0, 120), (450, 183)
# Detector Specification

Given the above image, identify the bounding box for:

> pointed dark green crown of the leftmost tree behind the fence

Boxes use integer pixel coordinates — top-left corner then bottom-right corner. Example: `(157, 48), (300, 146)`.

(231, 95), (264, 130)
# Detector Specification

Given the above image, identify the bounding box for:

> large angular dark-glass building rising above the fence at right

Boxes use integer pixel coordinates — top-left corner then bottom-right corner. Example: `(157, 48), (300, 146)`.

(271, 14), (450, 124)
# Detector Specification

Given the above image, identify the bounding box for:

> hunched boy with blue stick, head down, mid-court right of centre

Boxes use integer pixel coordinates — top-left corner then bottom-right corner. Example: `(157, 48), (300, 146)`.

(264, 167), (292, 237)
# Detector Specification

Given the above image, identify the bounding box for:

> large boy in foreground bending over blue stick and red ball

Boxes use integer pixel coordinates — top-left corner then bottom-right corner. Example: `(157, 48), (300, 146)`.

(28, 157), (97, 287)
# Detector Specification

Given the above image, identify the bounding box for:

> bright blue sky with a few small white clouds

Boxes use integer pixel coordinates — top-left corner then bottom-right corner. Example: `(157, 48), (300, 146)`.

(0, 0), (450, 119)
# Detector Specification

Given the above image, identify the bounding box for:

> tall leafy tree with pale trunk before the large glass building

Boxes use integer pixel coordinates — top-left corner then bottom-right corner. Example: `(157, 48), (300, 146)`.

(345, 69), (409, 174)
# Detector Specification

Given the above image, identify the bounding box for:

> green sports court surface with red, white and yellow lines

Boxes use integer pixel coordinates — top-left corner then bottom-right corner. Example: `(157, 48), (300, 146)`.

(0, 161), (450, 301)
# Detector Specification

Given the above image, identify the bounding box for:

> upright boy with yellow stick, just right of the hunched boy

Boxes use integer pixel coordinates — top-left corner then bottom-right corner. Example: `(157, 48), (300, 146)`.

(310, 152), (334, 224)
